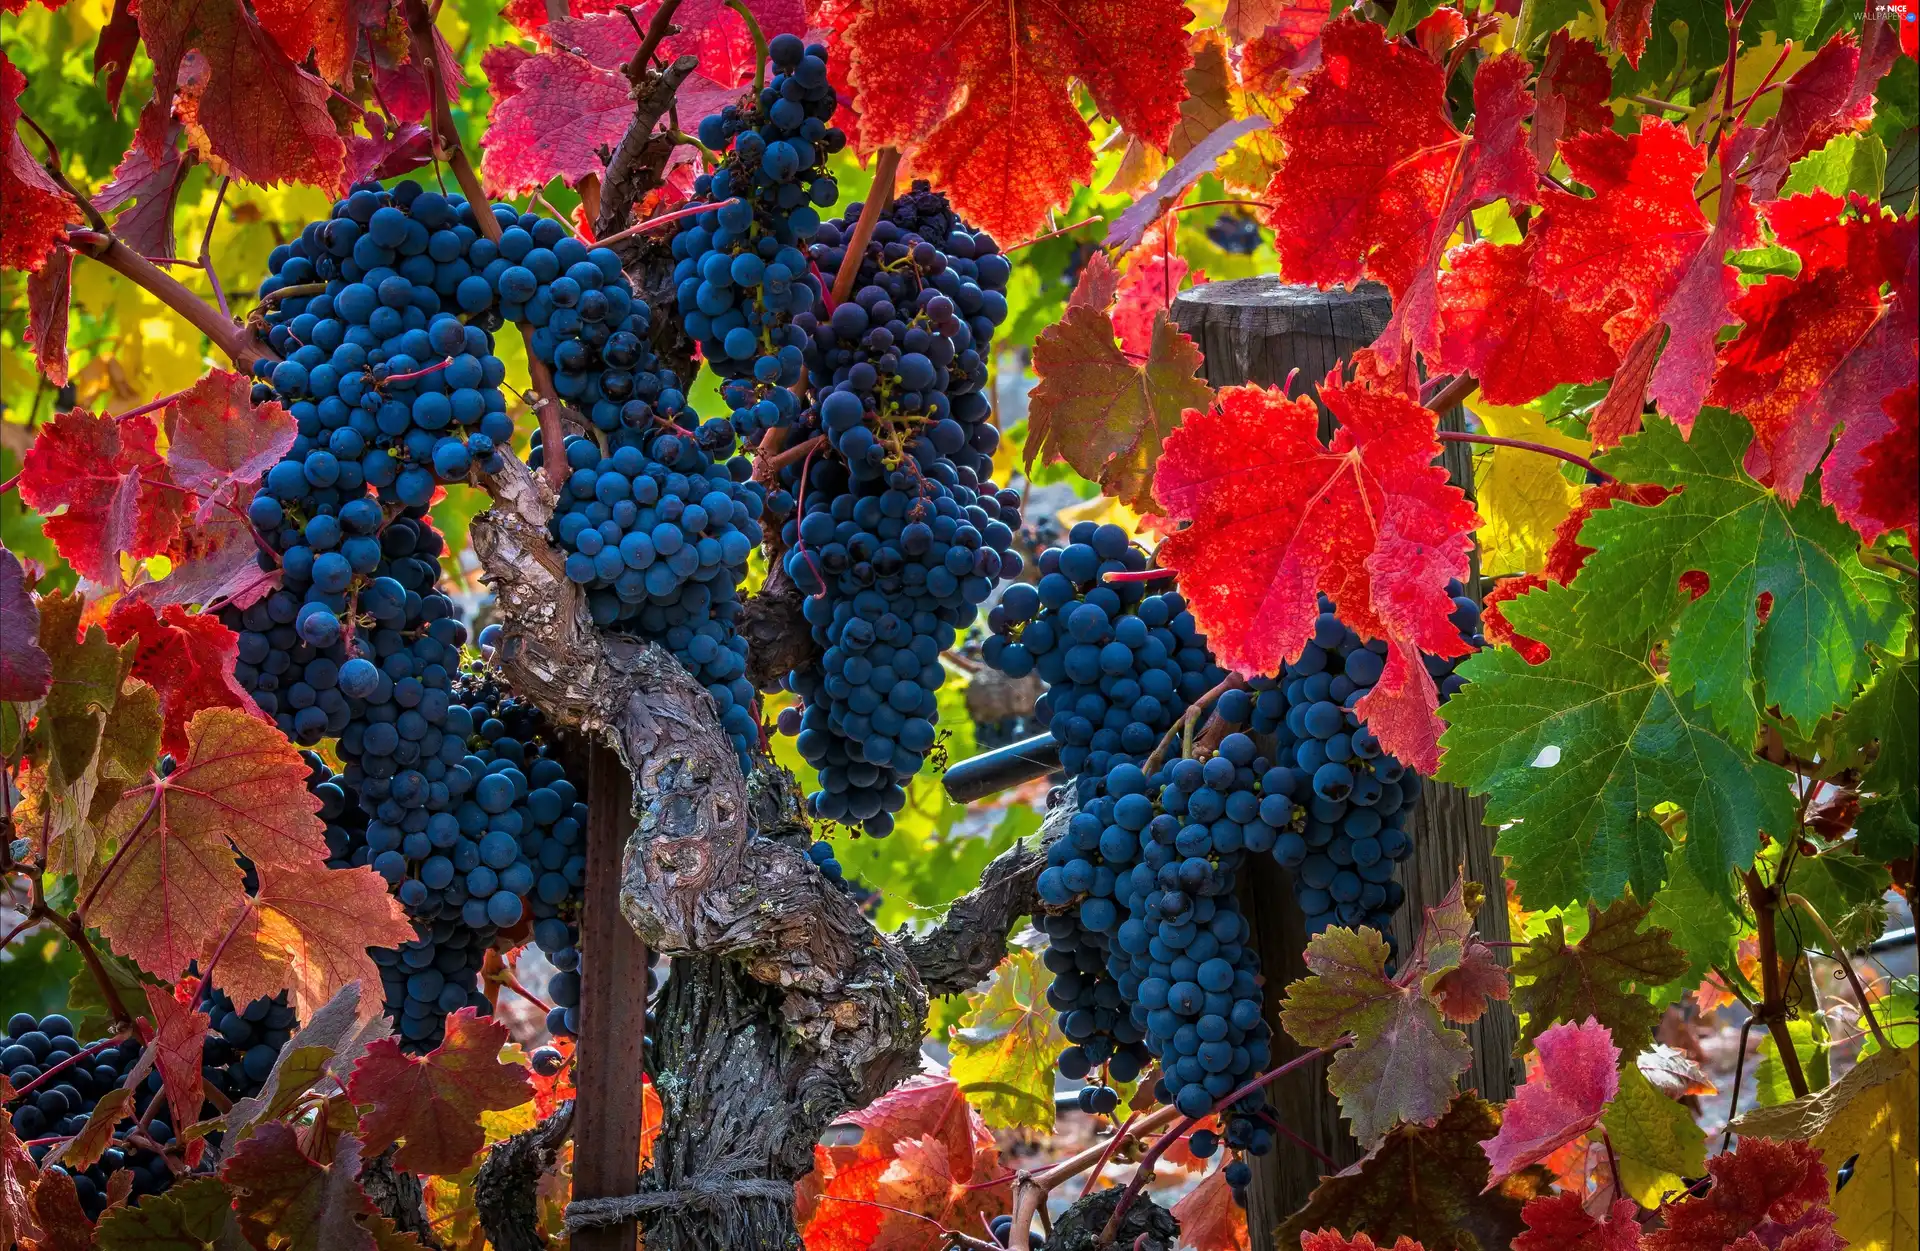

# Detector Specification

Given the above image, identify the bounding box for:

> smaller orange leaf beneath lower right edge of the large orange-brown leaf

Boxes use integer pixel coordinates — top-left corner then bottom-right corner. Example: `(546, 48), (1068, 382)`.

(221, 863), (415, 1021)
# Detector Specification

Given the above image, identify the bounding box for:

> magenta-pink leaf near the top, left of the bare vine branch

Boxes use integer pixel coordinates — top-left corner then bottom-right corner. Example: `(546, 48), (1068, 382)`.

(480, 52), (634, 196)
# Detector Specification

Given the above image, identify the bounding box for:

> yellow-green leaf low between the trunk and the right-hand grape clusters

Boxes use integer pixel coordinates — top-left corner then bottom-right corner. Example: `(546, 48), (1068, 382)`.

(950, 946), (1068, 1134)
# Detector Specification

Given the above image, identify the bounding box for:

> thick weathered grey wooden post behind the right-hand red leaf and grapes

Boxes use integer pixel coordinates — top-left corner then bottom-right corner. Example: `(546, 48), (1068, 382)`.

(1173, 278), (1515, 1251)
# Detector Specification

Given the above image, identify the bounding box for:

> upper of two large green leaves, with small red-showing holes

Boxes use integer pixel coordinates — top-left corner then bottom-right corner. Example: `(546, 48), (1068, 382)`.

(1574, 409), (1907, 744)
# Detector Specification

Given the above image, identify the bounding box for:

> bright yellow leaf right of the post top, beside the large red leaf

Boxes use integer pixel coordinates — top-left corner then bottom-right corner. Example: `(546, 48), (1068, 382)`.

(1467, 395), (1594, 574)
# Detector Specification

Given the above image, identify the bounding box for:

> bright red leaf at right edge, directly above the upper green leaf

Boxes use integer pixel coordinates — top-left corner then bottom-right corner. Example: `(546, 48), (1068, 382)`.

(1707, 192), (1914, 501)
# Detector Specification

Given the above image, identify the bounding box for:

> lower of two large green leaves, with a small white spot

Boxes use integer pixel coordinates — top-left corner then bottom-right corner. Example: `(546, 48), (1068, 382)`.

(1440, 574), (1795, 908)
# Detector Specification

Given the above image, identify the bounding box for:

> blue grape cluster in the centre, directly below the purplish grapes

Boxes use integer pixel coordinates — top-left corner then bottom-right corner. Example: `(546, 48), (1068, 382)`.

(781, 445), (1023, 837)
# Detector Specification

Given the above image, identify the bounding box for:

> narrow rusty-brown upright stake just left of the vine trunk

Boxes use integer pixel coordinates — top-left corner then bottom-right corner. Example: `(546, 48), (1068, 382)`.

(572, 743), (647, 1251)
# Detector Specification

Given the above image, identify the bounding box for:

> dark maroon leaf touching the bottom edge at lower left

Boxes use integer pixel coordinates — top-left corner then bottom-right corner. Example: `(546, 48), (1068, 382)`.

(221, 1121), (420, 1251)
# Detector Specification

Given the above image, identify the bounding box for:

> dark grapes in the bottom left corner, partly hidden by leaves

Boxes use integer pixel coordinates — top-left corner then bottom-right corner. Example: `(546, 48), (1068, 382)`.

(0, 988), (296, 1220)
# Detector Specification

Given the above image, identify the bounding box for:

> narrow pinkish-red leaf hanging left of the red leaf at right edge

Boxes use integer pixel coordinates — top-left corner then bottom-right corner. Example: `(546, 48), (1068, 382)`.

(1647, 184), (1761, 430)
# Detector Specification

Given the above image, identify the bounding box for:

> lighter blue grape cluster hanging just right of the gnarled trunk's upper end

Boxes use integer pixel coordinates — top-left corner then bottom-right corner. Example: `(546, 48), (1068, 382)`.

(532, 422), (771, 758)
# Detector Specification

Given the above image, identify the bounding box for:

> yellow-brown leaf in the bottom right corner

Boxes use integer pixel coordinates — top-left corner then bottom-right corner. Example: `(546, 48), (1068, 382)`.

(1734, 1048), (1920, 1251)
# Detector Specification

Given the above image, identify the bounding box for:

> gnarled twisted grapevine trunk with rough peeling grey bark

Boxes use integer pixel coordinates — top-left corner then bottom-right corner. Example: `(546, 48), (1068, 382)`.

(472, 452), (1064, 1251)
